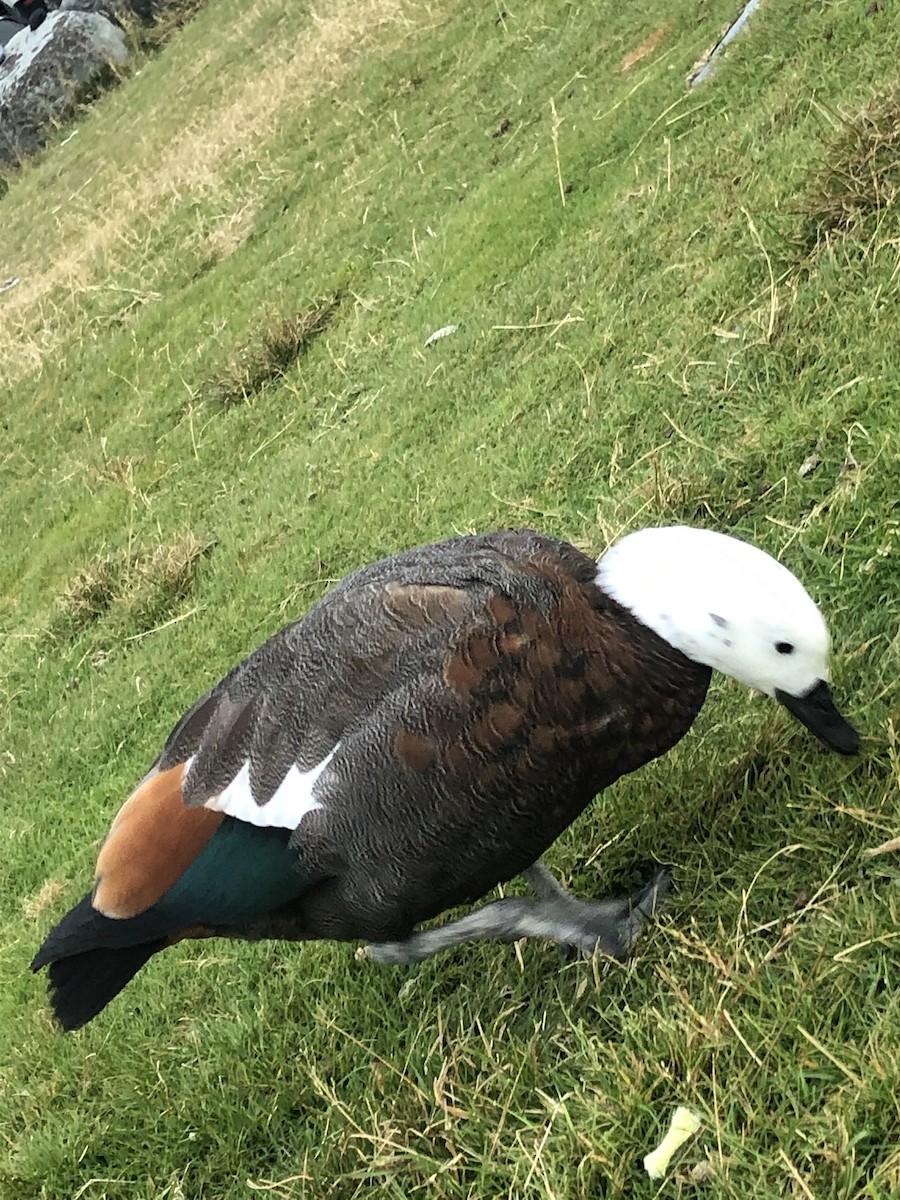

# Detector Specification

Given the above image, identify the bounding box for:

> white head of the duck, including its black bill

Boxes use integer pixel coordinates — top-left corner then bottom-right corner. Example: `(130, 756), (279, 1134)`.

(596, 526), (859, 754)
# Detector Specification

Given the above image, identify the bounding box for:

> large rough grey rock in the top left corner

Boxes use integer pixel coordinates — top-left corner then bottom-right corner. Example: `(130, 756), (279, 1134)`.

(0, 12), (128, 163)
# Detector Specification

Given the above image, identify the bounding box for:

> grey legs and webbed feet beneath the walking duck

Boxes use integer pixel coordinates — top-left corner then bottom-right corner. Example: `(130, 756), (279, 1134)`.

(366, 863), (671, 964)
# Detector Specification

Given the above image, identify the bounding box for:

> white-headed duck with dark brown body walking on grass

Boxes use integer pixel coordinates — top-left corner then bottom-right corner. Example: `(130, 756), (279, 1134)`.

(32, 527), (859, 1030)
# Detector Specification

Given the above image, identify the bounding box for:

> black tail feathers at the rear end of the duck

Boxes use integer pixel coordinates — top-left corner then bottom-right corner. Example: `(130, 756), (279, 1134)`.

(31, 895), (169, 1030)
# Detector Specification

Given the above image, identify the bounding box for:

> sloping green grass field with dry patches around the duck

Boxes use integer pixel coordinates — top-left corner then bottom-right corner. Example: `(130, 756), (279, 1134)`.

(0, 0), (900, 1200)
